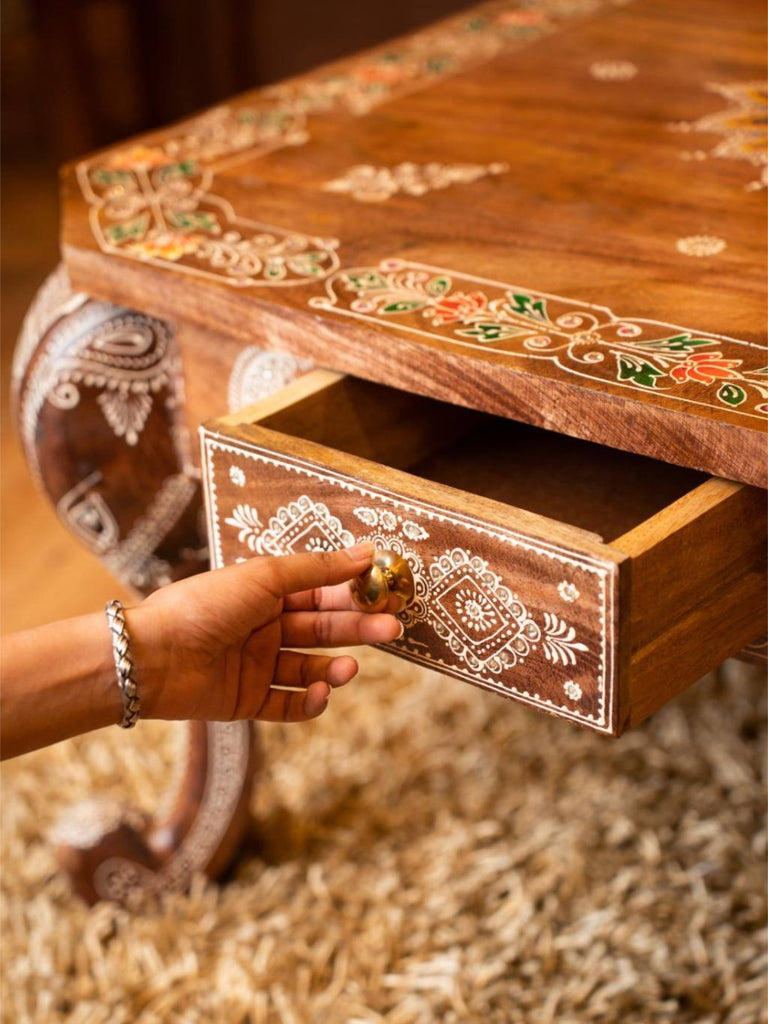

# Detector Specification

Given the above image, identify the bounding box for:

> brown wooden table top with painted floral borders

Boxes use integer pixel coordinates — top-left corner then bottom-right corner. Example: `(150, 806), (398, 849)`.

(62, 0), (768, 486)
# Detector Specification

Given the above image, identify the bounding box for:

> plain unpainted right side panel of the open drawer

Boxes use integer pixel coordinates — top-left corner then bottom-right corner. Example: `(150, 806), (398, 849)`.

(613, 479), (768, 728)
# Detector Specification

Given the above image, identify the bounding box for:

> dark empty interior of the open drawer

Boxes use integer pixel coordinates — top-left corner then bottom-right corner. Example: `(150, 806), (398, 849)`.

(260, 377), (708, 543)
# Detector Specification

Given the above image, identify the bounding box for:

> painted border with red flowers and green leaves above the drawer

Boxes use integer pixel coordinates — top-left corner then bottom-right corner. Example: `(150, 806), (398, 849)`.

(309, 259), (768, 419)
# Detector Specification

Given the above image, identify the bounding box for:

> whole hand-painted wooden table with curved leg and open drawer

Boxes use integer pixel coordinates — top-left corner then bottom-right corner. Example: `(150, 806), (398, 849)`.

(15, 0), (768, 899)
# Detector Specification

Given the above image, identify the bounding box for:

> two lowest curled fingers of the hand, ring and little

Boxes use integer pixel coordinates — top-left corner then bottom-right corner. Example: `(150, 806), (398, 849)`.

(253, 650), (357, 722)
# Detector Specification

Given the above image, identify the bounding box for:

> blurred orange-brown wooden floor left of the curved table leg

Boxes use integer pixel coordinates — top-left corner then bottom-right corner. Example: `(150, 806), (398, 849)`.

(0, 165), (130, 633)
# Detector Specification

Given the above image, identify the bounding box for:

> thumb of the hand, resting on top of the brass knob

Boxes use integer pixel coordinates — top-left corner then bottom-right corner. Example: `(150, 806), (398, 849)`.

(256, 542), (374, 598)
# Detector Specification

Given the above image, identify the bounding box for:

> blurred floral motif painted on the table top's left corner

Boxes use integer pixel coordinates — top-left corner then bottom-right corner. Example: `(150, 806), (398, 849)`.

(78, 161), (338, 288)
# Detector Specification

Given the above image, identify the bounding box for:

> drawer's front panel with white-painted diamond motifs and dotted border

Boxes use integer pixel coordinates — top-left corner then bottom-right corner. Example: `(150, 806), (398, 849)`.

(203, 431), (618, 733)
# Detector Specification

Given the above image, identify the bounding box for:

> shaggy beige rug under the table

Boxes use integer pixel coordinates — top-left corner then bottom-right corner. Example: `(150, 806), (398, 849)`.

(2, 652), (768, 1024)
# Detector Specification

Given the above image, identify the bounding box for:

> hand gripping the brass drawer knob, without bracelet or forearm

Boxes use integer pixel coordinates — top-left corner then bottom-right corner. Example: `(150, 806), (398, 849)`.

(125, 544), (401, 722)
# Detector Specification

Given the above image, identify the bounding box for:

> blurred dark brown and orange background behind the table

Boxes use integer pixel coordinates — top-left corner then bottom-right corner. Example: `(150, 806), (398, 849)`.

(0, 0), (468, 632)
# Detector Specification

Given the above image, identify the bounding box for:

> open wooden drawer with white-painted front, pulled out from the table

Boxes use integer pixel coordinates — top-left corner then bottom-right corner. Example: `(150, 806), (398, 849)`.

(201, 371), (766, 735)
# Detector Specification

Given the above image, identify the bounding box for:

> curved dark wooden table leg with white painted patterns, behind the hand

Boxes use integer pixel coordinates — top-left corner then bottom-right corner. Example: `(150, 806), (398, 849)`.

(13, 267), (256, 902)
